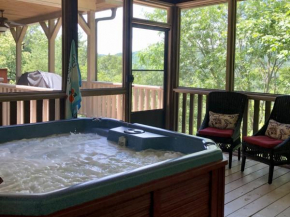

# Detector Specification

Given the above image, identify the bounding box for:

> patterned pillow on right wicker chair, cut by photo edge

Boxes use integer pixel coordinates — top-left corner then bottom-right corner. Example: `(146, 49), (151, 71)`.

(265, 119), (290, 140)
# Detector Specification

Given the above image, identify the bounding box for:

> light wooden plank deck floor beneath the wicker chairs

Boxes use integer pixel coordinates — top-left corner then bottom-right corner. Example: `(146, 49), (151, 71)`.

(225, 155), (290, 217)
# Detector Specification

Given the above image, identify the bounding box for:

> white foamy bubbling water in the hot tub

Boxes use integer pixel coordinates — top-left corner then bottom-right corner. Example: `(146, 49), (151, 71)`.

(0, 134), (183, 193)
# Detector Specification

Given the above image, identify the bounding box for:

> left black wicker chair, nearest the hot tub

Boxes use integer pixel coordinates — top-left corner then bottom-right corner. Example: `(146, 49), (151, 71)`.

(197, 91), (248, 168)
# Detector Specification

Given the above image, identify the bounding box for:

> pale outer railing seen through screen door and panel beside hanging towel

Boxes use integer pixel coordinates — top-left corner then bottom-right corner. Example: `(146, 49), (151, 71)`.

(79, 81), (163, 120)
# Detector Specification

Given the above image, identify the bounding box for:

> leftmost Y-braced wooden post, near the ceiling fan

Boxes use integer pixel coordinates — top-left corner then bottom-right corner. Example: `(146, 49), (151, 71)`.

(10, 26), (28, 81)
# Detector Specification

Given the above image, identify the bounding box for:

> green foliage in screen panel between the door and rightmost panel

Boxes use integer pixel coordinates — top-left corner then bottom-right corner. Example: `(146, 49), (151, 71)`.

(179, 4), (227, 89)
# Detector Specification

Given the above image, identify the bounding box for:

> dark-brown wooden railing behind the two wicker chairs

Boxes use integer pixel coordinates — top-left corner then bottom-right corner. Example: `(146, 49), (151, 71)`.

(174, 88), (276, 135)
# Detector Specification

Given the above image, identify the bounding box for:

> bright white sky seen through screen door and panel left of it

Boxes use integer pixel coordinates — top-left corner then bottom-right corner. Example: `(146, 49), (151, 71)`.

(79, 5), (162, 54)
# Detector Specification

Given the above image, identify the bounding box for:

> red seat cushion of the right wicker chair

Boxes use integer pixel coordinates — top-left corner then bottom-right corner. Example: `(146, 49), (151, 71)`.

(243, 136), (283, 148)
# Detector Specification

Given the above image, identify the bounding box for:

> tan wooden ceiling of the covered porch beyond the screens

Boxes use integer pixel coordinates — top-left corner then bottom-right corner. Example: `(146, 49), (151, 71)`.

(0, 0), (123, 24)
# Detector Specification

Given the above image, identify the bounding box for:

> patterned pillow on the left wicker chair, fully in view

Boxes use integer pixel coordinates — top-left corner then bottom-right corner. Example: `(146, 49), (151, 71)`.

(208, 111), (239, 130)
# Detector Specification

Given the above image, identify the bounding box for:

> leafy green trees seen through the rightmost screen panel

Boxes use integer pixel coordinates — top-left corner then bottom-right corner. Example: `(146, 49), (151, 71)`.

(235, 0), (290, 94)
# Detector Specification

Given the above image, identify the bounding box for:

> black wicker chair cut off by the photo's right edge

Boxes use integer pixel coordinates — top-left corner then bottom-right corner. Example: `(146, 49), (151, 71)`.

(241, 96), (290, 184)
